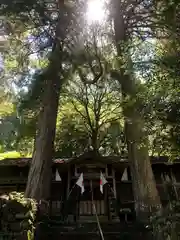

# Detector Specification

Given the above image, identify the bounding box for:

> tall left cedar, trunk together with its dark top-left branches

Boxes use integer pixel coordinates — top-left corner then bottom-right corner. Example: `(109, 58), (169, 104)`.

(0, 0), (69, 200)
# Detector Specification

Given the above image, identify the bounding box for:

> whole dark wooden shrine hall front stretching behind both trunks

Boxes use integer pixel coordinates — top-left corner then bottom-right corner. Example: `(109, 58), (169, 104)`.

(0, 153), (180, 221)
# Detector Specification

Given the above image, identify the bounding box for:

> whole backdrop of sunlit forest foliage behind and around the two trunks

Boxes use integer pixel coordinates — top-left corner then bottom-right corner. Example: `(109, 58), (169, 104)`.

(0, 1), (179, 157)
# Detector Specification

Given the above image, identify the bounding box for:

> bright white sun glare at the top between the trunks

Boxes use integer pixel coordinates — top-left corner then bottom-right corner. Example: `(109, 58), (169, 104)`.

(87, 0), (105, 23)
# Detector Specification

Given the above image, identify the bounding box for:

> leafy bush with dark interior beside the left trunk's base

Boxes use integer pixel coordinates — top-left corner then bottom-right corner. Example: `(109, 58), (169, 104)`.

(0, 192), (37, 239)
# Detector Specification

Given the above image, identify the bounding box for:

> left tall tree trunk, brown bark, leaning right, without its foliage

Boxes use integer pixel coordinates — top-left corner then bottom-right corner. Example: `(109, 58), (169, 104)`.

(25, 0), (65, 200)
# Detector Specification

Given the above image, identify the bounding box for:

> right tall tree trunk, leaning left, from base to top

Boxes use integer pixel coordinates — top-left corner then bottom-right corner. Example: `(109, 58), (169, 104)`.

(112, 0), (161, 220)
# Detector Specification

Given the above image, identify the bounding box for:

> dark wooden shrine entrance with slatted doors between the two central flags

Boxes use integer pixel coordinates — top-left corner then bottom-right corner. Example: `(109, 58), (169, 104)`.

(64, 162), (116, 222)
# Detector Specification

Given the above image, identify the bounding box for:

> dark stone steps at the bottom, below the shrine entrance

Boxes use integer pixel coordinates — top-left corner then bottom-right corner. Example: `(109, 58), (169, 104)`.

(35, 221), (151, 240)
